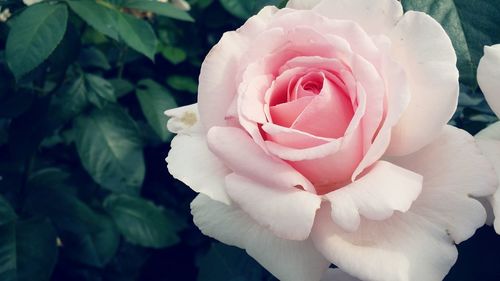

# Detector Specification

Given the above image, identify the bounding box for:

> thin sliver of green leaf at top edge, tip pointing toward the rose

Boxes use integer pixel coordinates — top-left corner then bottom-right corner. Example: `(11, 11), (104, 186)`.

(123, 0), (194, 22)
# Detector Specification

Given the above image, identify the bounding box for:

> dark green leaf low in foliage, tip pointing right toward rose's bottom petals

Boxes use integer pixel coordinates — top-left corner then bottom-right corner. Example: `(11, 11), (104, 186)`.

(104, 195), (180, 248)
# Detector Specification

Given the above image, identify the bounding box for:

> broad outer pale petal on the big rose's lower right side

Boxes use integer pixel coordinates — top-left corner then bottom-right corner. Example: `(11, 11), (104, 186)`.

(390, 126), (497, 243)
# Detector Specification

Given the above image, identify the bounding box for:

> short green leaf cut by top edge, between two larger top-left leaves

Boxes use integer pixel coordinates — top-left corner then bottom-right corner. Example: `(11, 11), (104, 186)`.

(66, 0), (118, 40)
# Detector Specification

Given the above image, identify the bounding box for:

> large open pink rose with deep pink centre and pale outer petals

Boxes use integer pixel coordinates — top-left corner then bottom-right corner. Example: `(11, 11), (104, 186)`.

(166, 0), (496, 281)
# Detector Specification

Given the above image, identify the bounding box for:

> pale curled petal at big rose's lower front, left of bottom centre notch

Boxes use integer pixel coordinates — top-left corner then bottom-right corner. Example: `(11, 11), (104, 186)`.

(226, 171), (321, 240)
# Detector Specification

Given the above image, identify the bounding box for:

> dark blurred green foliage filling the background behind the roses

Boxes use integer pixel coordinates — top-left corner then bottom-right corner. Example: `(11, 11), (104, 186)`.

(0, 0), (500, 281)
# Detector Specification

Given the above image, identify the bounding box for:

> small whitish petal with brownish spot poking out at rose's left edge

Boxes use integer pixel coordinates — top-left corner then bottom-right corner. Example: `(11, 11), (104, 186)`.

(165, 103), (203, 135)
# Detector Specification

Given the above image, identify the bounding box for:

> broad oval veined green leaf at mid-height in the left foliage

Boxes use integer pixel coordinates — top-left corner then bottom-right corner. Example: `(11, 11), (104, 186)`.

(75, 105), (145, 194)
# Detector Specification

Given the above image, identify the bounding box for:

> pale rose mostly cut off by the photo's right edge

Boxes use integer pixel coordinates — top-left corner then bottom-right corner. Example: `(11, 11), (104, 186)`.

(476, 44), (500, 234)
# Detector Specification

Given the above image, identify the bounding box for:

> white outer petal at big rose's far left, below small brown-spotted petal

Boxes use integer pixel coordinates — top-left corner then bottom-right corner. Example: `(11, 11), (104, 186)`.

(166, 134), (231, 204)
